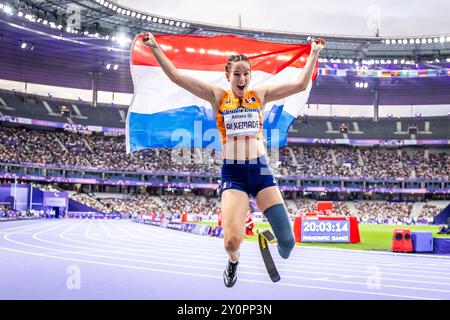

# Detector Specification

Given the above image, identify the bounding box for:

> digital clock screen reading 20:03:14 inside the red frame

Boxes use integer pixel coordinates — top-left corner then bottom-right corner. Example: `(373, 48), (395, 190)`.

(301, 220), (350, 242)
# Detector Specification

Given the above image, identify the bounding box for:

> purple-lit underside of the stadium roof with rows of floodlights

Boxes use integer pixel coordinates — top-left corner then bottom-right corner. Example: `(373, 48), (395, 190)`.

(0, 0), (450, 105)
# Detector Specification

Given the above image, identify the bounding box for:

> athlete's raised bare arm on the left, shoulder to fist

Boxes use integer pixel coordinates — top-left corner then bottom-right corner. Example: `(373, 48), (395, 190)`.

(142, 33), (225, 111)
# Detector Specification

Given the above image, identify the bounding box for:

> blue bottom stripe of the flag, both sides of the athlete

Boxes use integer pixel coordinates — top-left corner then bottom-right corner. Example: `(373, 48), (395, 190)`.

(128, 105), (295, 152)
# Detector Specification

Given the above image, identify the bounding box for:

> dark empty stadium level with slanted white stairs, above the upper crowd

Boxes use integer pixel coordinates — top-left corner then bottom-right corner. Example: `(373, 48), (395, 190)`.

(0, 91), (450, 140)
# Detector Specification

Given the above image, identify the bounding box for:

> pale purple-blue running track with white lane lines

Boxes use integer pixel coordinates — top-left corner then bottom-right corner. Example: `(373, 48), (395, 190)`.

(0, 220), (450, 300)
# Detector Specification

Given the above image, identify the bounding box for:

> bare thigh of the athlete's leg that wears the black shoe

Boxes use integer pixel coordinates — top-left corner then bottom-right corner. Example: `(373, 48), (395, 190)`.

(221, 189), (249, 236)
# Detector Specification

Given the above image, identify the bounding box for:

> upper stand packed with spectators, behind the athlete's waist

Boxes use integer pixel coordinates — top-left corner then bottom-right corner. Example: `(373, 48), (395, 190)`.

(0, 127), (450, 179)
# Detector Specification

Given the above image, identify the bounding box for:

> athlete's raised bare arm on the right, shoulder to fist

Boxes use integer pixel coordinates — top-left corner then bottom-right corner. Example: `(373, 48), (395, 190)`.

(255, 38), (326, 103)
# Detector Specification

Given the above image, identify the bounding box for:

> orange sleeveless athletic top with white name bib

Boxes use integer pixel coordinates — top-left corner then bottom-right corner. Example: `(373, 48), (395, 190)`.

(216, 90), (263, 144)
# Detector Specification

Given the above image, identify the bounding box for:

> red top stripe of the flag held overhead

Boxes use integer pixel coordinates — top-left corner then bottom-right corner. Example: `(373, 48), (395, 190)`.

(131, 35), (319, 79)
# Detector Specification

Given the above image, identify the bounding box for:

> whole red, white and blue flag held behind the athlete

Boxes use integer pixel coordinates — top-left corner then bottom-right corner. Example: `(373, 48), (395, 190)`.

(126, 35), (318, 153)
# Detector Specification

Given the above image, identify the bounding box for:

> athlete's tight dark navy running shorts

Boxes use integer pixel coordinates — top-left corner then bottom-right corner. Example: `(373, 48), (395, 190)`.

(220, 156), (277, 197)
